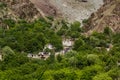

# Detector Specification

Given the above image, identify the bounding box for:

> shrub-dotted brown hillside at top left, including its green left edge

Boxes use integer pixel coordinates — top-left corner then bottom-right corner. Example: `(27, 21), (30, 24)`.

(0, 0), (41, 28)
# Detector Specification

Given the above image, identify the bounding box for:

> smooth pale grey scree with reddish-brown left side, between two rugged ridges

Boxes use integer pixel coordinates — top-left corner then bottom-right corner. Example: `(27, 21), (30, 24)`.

(30, 0), (103, 22)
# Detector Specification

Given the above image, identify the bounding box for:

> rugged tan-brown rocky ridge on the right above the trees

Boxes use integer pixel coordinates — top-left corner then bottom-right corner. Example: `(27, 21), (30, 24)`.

(85, 0), (120, 34)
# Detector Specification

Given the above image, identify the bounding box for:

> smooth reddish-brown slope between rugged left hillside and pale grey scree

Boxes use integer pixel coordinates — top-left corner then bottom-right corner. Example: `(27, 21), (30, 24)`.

(30, 0), (58, 16)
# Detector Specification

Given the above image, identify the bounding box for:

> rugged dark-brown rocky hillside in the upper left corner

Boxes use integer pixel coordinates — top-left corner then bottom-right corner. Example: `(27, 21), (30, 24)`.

(0, 0), (40, 21)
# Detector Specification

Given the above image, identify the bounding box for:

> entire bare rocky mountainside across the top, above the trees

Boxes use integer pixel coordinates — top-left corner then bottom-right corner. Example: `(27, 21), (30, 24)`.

(0, 0), (120, 33)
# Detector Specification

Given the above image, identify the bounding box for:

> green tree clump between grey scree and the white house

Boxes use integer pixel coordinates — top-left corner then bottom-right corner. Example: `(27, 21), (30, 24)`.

(57, 21), (82, 38)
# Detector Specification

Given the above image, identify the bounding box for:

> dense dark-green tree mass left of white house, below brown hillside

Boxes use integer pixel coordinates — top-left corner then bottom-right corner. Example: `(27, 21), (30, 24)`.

(0, 19), (62, 52)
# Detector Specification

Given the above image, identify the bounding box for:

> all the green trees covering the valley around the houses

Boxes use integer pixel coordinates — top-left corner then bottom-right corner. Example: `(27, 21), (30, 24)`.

(0, 18), (120, 80)
